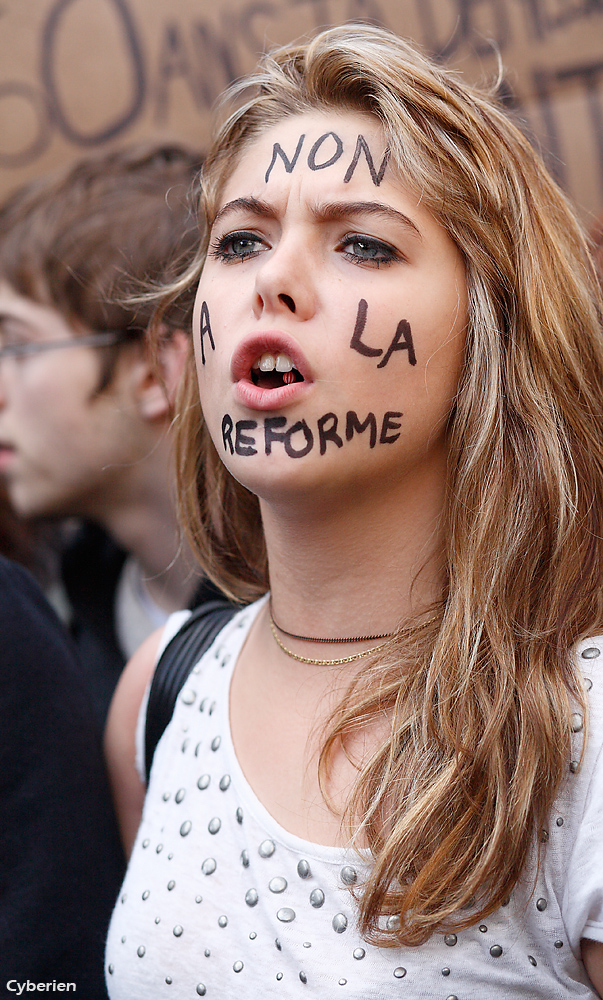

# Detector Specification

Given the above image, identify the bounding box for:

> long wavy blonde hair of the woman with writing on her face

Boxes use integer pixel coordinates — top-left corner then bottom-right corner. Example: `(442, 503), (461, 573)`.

(163, 25), (603, 946)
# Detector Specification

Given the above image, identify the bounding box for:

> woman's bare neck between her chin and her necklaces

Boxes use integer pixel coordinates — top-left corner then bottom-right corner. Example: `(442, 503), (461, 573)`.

(261, 462), (443, 638)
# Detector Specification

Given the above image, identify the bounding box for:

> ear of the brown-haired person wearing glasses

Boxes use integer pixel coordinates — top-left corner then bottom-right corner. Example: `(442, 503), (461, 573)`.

(137, 330), (191, 421)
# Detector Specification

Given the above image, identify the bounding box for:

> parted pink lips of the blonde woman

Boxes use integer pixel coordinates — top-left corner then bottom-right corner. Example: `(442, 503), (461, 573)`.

(230, 330), (313, 410)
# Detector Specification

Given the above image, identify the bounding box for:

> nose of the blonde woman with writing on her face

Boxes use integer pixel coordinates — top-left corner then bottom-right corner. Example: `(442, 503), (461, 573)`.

(254, 234), (316, 321)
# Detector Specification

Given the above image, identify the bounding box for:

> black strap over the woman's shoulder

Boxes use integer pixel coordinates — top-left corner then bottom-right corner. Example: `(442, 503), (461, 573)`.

(144, 601), (239, 783)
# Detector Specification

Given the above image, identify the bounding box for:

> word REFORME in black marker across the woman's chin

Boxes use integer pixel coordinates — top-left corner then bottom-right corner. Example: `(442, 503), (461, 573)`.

(222, 410), (402, 458)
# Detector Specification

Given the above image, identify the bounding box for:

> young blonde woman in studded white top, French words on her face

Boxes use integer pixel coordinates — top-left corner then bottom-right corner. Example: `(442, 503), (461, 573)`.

(106, 26), (603, 1000)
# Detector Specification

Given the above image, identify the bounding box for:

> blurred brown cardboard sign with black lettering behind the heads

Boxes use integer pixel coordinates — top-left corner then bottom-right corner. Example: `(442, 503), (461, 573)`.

(0, 0), (603, 228)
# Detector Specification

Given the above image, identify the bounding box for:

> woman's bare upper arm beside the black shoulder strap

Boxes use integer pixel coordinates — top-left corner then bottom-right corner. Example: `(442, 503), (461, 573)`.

(105, 629), (163, 858)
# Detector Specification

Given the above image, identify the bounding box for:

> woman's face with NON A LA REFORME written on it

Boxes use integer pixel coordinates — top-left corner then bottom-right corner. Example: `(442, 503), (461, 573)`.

(194, 112), (467, 508)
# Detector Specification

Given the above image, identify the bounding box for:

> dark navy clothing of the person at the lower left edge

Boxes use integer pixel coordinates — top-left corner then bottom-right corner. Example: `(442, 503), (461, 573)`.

(0, 556), (124, 1000)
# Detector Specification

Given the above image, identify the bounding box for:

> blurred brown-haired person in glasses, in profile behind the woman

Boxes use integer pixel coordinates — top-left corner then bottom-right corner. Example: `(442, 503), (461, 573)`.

(0, 144), (219, 726)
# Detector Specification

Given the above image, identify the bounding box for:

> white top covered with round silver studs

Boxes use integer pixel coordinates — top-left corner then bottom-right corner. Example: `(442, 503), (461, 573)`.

(105, 602), (603, 1000)
